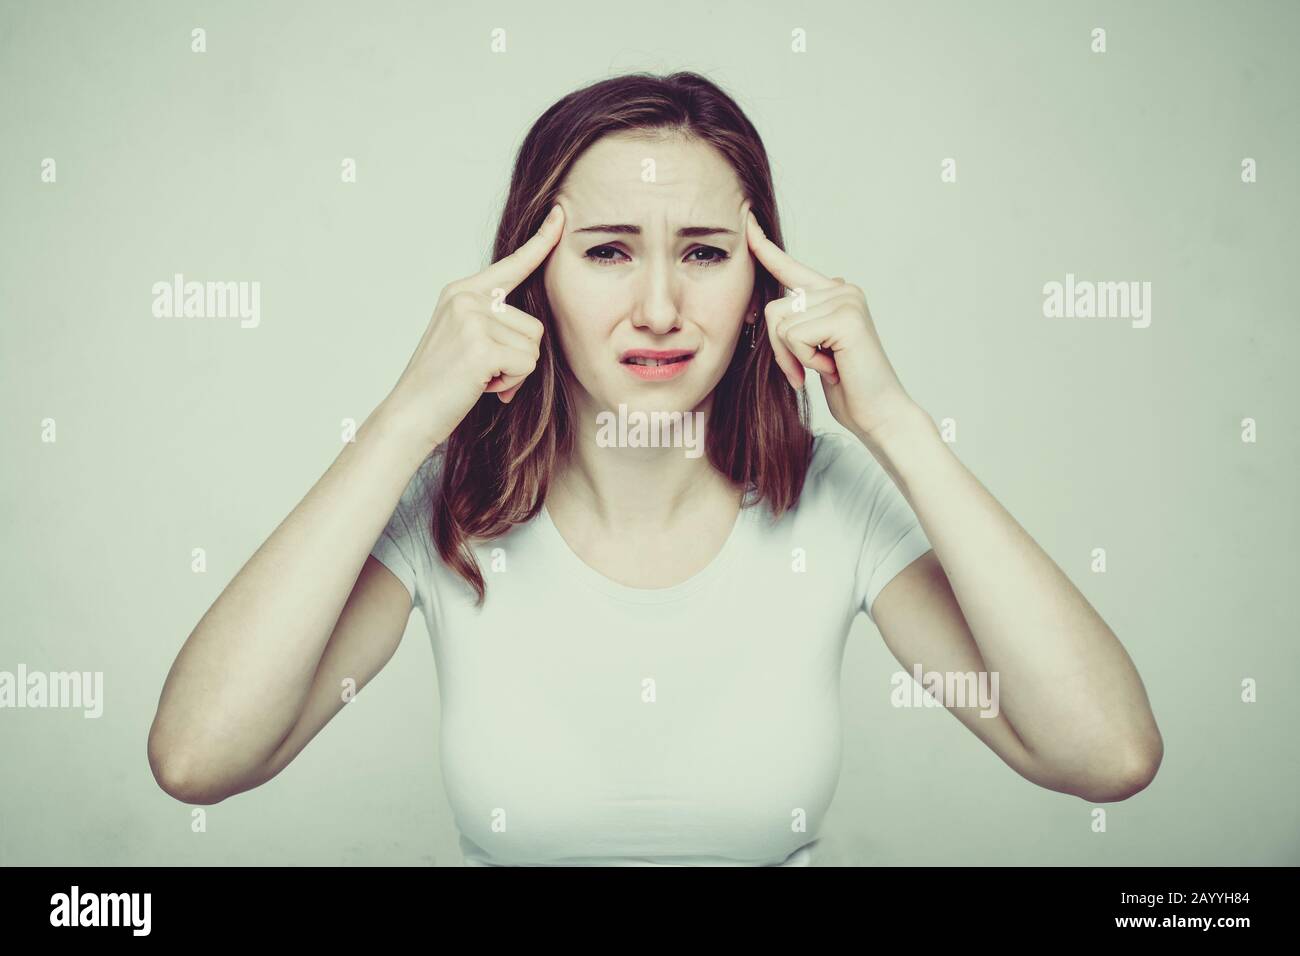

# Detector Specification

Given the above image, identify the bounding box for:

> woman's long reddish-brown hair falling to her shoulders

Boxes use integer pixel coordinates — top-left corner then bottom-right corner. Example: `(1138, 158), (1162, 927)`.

(432, 73), (813, 605)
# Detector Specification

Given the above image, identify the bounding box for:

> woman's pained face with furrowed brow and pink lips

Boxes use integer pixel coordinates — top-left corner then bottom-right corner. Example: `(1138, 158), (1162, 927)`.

(543, 128), (754, 415)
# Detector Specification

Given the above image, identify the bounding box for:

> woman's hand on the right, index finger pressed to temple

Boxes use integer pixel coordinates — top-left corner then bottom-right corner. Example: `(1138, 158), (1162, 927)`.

(746, 212), (915, 438)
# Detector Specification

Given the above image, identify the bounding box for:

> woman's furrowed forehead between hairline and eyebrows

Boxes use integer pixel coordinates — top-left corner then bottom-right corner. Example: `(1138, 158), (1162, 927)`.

(559, 133), (744, 228)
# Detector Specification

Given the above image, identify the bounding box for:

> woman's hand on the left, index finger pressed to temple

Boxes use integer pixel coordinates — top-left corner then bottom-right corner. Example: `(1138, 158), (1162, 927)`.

(385, 204), (564, 450)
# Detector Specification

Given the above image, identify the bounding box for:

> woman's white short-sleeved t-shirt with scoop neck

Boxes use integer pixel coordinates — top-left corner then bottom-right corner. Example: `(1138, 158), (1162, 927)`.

(372, 432), (931, 866)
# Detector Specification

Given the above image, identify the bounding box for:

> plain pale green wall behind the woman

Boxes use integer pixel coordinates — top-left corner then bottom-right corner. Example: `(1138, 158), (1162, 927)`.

(0, 1), (1300, 865)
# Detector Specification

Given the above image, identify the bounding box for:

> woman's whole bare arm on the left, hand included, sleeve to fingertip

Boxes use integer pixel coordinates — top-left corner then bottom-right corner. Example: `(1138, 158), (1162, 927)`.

(148, 207), (564, 804)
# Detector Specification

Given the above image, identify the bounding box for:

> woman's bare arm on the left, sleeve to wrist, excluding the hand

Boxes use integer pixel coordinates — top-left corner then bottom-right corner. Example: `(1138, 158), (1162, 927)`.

(148, 405), (432, 803)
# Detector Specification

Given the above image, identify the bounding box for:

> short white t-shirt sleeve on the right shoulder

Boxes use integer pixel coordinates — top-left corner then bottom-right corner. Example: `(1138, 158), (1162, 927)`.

(828, 436), (932, 622)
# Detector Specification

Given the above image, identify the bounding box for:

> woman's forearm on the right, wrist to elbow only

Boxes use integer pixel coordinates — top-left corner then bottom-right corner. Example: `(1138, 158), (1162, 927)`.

(858, 406), (1161, 779)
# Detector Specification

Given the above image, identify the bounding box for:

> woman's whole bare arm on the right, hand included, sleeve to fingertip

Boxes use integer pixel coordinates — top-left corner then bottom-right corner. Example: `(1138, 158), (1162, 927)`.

(746, 209), (1165, 801)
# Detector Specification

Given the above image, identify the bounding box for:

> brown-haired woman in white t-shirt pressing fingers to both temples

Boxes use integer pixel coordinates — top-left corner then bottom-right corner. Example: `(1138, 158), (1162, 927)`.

(150, 73), (1162, 865)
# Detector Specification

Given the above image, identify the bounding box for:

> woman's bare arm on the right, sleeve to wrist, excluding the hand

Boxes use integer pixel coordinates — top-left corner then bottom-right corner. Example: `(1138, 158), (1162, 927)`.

(859, 407), (1164, 803)
